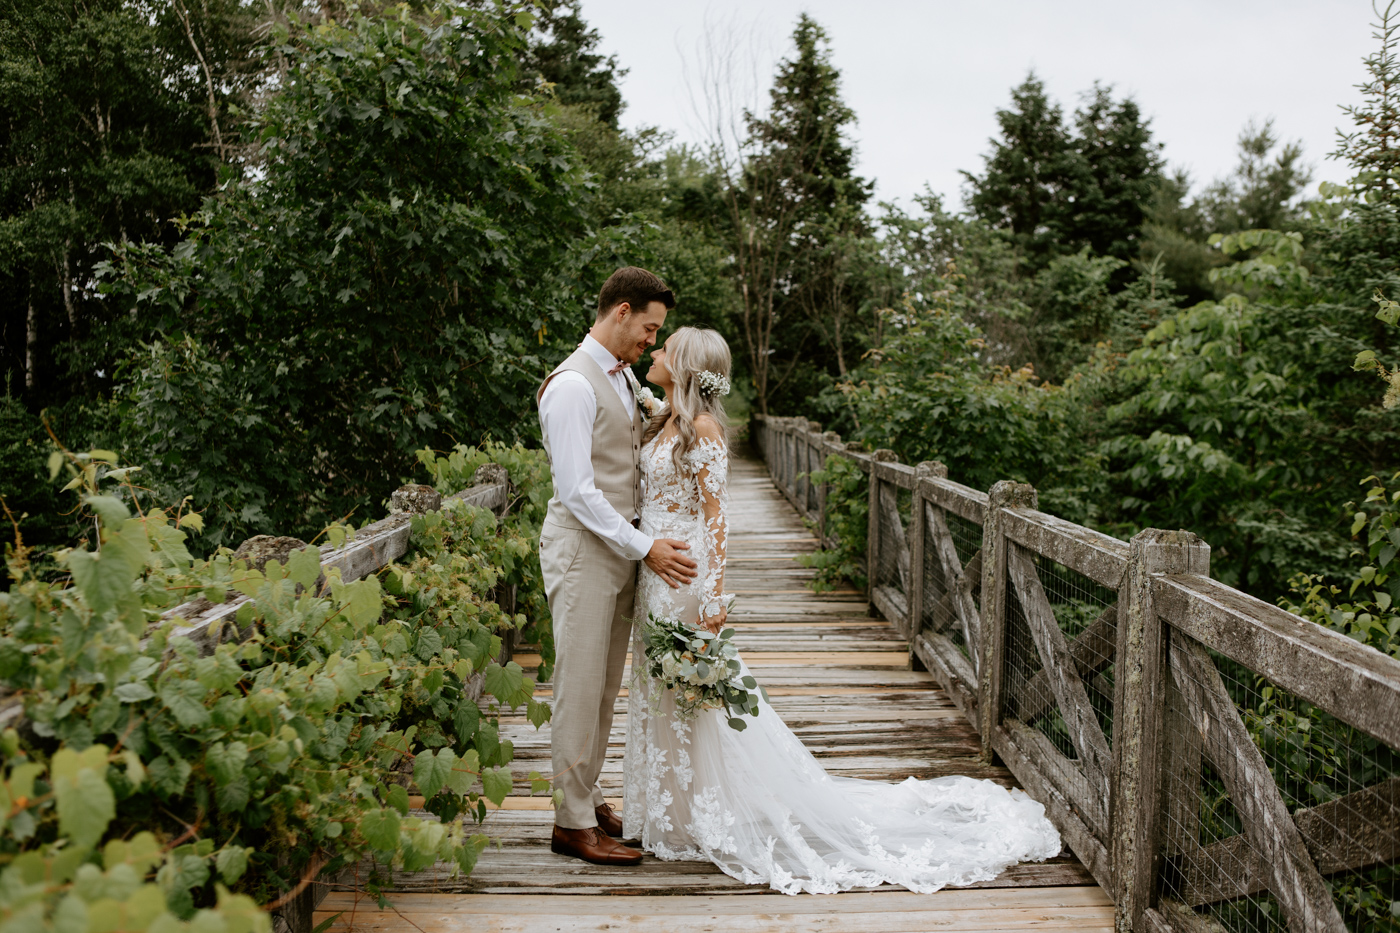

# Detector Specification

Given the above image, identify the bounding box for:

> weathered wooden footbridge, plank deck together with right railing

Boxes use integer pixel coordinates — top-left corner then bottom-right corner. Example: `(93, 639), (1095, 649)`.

(308, 417), (1400, 933)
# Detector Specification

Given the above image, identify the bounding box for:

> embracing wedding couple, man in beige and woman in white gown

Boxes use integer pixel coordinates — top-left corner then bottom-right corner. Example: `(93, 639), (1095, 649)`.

(536, 266), (1060, 894)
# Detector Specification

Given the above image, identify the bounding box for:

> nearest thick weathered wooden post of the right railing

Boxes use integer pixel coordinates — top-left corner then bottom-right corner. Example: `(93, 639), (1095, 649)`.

(1109, 528), (1211, 933)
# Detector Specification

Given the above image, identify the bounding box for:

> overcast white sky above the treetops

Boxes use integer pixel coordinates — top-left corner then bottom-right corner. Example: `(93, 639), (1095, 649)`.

(582, 0), (1376, 206)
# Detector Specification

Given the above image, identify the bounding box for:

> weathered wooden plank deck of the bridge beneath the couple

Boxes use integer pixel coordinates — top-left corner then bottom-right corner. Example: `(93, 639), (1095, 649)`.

(315, 448), (1113, 933)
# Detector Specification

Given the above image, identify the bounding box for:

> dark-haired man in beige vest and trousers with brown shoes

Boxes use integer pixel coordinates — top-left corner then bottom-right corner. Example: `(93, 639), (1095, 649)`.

(535, 266), (696, 864)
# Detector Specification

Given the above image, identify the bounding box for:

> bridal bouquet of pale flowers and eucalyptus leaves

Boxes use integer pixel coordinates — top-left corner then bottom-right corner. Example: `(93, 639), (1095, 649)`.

(643, 614), (763, 731)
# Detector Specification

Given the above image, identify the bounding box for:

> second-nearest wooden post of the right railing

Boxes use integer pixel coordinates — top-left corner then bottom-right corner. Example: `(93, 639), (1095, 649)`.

(977, 479), (1040, 762)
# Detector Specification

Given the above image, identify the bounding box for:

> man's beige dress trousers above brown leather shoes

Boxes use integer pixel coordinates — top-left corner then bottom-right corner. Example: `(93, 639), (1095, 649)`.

(539, 518), (637, 829)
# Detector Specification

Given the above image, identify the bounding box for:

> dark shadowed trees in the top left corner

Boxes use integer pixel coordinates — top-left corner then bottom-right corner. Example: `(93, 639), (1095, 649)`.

(0, 0), (252, 410)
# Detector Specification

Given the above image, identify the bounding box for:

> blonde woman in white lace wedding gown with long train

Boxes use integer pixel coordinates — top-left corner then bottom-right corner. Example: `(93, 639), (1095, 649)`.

(622, 328), (1060, 894)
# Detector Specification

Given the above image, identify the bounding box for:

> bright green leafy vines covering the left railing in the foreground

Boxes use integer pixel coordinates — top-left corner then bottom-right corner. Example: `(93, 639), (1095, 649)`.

(0, 439), (547, 933)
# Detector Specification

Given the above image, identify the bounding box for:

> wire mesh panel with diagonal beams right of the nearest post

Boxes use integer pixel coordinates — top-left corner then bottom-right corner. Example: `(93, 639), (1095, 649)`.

(1159, 632), (1400, 933)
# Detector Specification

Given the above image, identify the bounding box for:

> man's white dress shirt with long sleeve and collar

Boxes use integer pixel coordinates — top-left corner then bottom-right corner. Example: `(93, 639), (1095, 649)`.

(539, 335), (652, 560)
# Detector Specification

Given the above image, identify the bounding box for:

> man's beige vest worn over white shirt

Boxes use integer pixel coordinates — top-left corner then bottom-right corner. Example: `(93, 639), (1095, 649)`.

(535, 347), (645, 528)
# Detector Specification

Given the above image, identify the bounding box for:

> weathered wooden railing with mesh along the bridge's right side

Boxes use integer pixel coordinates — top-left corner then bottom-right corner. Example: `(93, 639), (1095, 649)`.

(752, 416), (1400, 933)
